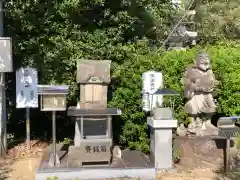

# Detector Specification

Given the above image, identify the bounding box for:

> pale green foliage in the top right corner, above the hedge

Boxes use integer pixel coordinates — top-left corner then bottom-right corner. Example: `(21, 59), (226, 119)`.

(196, 0), (240, 43)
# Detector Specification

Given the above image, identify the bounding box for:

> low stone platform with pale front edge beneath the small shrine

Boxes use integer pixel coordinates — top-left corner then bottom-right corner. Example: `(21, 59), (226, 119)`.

(36, 144), (156, 180)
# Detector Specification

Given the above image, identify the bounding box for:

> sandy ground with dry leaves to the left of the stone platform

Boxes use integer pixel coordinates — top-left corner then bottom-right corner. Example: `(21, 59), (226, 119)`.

(0, 140), (47, 180)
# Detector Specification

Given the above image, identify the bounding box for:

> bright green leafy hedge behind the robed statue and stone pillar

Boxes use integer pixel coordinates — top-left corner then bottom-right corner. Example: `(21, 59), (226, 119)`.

(110, 43), (240, 151)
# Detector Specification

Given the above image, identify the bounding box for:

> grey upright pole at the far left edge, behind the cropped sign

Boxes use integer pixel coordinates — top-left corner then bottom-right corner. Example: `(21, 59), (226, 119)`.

(0, 0), (7, 156)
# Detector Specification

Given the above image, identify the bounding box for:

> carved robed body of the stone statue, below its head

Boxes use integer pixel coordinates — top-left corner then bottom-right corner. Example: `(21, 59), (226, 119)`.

(184, 65), (216, 115)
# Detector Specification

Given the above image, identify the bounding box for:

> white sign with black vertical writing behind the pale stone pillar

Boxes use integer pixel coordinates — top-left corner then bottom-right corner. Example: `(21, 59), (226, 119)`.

(142, 71), (163, 111)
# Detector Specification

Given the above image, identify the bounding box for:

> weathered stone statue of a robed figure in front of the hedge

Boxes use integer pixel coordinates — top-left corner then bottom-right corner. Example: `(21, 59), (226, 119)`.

(183, 52), (217, 134)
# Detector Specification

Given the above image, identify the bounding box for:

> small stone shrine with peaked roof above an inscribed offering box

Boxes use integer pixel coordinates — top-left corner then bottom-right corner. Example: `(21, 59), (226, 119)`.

(68, 60), (121, 166)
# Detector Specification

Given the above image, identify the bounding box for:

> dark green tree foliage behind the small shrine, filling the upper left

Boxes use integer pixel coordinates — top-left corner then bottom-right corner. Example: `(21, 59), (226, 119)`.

(5, 0), (175, 142)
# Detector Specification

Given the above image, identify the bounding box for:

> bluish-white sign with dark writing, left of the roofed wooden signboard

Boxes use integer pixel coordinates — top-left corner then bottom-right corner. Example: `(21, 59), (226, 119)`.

(16, 68), (38, 108)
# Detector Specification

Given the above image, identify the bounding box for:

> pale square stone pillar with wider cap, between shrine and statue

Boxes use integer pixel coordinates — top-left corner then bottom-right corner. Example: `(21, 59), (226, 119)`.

(147, 117), (177, 169)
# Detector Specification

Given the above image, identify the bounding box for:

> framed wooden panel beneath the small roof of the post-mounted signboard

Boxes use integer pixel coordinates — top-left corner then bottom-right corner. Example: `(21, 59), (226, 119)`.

(41, 94), (66, 111)
